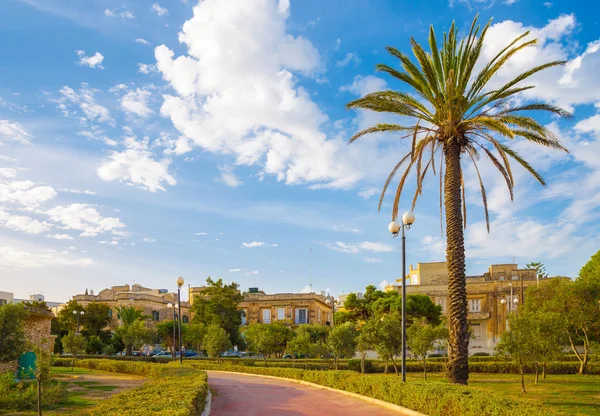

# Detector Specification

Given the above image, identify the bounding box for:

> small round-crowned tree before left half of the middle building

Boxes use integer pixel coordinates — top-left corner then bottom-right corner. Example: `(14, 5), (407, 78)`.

(244, 323), (294, 366)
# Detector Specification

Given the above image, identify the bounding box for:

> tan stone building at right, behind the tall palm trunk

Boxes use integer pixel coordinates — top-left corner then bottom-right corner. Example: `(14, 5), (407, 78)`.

(386, 262), (542, 352)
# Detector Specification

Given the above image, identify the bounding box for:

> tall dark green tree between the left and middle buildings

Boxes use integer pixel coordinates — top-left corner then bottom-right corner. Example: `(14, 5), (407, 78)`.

(191, 277), (244, 345)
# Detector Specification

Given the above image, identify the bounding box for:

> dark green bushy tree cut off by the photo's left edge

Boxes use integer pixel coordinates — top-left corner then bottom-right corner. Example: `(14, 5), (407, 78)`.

(0, 304), (28, 363)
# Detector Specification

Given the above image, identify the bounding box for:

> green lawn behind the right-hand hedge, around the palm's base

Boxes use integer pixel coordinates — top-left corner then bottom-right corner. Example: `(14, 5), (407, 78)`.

(407, 373), (600, 416)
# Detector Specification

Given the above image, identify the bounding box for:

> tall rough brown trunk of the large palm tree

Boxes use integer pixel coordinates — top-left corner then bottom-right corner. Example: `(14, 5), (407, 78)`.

(444, 139), (469, 384)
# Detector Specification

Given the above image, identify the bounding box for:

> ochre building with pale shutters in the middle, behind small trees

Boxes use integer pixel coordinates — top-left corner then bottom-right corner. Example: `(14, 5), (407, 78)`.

(189, 287), (333, 326)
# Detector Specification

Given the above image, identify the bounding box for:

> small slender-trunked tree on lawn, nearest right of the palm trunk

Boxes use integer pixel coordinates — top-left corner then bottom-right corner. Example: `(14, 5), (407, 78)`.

(496, 311), (538, 393)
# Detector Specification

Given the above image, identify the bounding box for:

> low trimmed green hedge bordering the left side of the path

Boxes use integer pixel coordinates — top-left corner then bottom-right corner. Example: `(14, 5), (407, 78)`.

(54, 358), (208, 416)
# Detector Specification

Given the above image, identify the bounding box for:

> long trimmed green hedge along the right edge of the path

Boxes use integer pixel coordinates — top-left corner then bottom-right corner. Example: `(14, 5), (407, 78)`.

(188, 361), (563, 416)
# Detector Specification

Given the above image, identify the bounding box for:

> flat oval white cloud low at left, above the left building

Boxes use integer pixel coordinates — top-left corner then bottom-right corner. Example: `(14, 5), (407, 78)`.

(47, 204), (125, 237)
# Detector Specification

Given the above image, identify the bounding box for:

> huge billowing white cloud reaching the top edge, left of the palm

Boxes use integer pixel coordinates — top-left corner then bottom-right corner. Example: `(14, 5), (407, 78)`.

(155, 0), (377, 188)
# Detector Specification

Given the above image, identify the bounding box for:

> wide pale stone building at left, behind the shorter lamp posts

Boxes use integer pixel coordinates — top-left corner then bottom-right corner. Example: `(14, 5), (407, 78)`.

(70, 284), (190, 330)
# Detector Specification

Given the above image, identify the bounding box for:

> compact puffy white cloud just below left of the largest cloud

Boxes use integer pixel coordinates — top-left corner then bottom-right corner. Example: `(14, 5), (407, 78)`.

(97, 132), (177, 192)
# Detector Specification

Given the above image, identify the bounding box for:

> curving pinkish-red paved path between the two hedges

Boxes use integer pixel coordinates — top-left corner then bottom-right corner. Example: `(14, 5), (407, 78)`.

(208, 371), (408, 416)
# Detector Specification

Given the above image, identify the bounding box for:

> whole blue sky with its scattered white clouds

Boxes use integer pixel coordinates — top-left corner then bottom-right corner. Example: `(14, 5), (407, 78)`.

(0, 0), (600, 300)
